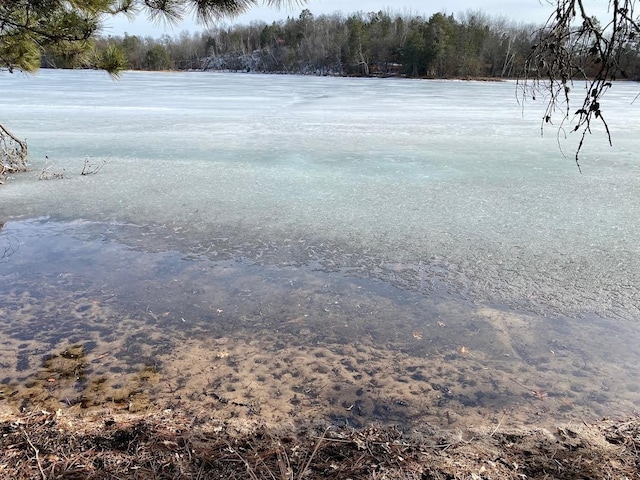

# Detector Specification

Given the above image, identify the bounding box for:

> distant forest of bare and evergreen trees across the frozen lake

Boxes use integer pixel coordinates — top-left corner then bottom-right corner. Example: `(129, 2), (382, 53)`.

(42, 10), (640, 80)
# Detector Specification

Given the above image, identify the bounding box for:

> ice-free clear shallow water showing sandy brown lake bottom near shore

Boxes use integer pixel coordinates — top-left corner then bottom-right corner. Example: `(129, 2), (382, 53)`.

(0, 218), (640, 428)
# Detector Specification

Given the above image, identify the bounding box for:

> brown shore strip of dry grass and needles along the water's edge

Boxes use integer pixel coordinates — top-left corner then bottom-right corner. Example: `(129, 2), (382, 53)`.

(0, 411), (640, 480)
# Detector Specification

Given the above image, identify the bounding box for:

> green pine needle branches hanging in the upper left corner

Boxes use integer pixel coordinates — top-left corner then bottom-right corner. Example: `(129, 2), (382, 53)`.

(0, 0), (304, 74)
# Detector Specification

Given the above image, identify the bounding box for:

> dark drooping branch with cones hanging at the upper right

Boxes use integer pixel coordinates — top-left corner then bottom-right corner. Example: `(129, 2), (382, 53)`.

(519, 0), (640, 168)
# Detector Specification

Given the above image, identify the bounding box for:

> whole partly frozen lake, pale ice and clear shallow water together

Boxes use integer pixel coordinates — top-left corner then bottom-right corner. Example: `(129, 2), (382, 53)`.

(0, 71), (640, 424)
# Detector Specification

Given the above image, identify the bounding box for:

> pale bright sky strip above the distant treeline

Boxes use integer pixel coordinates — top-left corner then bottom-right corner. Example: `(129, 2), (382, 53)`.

(103, 0), (609, 37)
